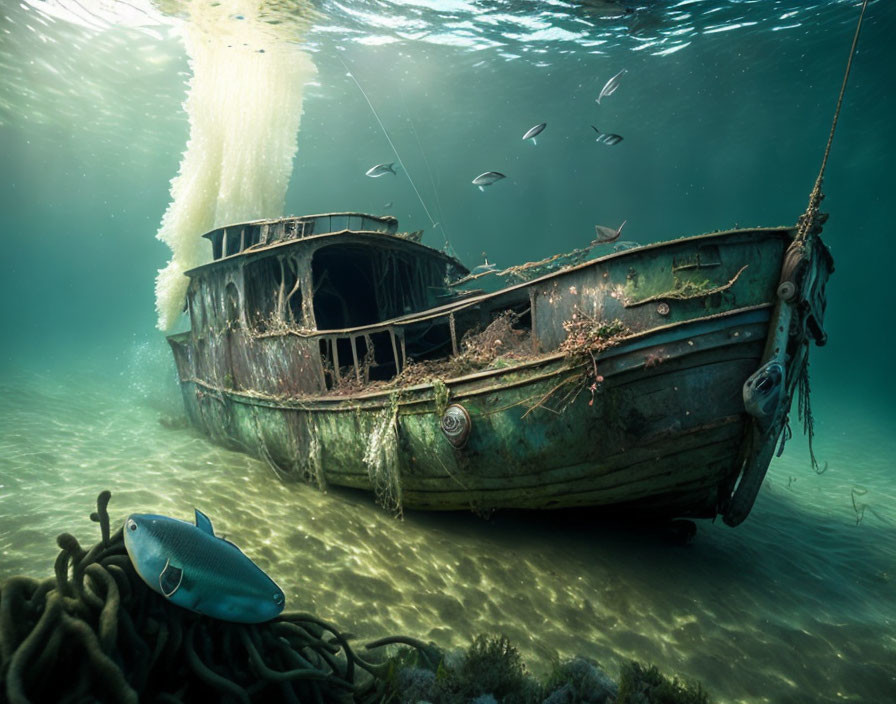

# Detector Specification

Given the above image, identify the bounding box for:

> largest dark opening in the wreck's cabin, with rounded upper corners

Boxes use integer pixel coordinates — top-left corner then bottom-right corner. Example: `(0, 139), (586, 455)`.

(311, 245), (382, 328)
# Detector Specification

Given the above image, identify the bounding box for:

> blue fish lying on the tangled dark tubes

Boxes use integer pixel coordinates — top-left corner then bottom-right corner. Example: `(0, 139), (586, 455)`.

(124, 509), (286, 623)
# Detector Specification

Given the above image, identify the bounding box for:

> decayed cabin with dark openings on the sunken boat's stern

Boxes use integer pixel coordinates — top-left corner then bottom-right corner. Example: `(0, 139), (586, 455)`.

(170, 213), (512, 395)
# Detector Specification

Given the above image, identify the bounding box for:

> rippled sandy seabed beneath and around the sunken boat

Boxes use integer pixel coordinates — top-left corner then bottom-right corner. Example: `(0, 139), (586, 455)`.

(0, 360), (896, 702)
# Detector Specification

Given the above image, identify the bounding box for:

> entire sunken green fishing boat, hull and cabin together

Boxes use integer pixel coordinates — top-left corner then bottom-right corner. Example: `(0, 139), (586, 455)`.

(169, 215), (833, 524)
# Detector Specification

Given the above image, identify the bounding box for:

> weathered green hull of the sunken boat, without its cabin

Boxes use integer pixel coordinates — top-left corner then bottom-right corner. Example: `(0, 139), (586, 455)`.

(170, 220), (831, 523)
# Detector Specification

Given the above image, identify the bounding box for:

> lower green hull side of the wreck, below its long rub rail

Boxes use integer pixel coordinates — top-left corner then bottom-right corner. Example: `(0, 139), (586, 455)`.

(175, 308), (769, 516)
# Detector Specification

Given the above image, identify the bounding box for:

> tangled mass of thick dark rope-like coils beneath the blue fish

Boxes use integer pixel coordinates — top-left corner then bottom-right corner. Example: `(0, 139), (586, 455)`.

(0, 491), (424, 704)
